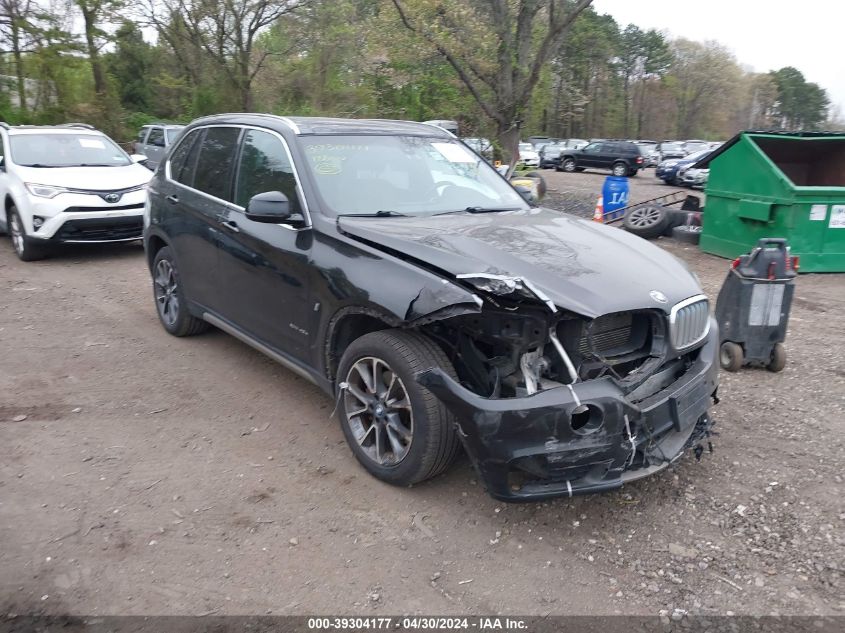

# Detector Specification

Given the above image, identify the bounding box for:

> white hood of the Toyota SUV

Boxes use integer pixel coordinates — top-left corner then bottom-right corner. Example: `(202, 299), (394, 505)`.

(16, 163), (153, 191)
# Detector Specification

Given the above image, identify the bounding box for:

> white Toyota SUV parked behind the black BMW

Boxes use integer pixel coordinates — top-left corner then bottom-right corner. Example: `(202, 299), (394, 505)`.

(0, 123), (152, 261)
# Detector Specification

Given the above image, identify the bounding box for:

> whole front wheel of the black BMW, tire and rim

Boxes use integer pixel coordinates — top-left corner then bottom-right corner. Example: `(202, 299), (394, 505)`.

(337, 330), (460, 486)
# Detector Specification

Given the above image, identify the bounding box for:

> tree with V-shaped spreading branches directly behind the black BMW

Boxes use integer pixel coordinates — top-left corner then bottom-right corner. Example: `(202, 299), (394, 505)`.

(393, 0), (592, 170)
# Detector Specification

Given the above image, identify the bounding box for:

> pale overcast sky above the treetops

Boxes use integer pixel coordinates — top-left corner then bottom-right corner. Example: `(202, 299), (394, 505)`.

(593, 0), (845, 115)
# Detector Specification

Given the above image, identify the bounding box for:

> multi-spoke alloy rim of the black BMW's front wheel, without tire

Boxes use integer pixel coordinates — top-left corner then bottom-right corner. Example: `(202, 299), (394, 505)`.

(343, 356), (414, 466)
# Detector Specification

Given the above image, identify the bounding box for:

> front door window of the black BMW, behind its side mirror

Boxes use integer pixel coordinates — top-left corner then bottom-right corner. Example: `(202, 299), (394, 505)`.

(235, 130), (302, 213)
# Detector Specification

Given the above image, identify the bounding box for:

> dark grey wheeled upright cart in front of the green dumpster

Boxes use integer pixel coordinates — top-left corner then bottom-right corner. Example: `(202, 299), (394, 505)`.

(716, 238), (798, 371)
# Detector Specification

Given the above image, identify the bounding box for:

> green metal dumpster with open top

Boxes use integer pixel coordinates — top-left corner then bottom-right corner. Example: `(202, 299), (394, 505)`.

(694, 132), (845, 272)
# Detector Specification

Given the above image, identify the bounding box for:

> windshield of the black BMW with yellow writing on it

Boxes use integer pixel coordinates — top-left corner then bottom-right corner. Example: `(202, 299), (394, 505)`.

(302, 135), (528, 215)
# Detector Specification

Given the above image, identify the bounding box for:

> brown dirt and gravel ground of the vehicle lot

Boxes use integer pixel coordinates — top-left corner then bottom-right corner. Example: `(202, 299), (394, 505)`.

(0, 171), (845, 615)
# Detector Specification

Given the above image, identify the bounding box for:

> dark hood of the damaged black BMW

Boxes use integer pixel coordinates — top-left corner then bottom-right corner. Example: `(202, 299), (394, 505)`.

(338, 209), (702, 318)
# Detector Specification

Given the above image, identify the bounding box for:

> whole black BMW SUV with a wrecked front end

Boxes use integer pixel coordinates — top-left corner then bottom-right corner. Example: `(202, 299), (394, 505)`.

(145, 114), (718, 501)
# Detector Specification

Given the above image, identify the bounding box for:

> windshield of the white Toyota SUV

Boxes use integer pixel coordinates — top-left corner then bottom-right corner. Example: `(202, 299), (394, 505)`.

(9, 133), (132, 167)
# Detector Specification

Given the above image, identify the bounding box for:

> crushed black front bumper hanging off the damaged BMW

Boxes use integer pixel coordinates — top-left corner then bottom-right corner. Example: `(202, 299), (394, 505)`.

(417, 323), (719, 501)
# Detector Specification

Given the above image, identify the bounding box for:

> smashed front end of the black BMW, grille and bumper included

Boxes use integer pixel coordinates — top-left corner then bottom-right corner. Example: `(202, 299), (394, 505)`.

(417, 273), (718, 501)
